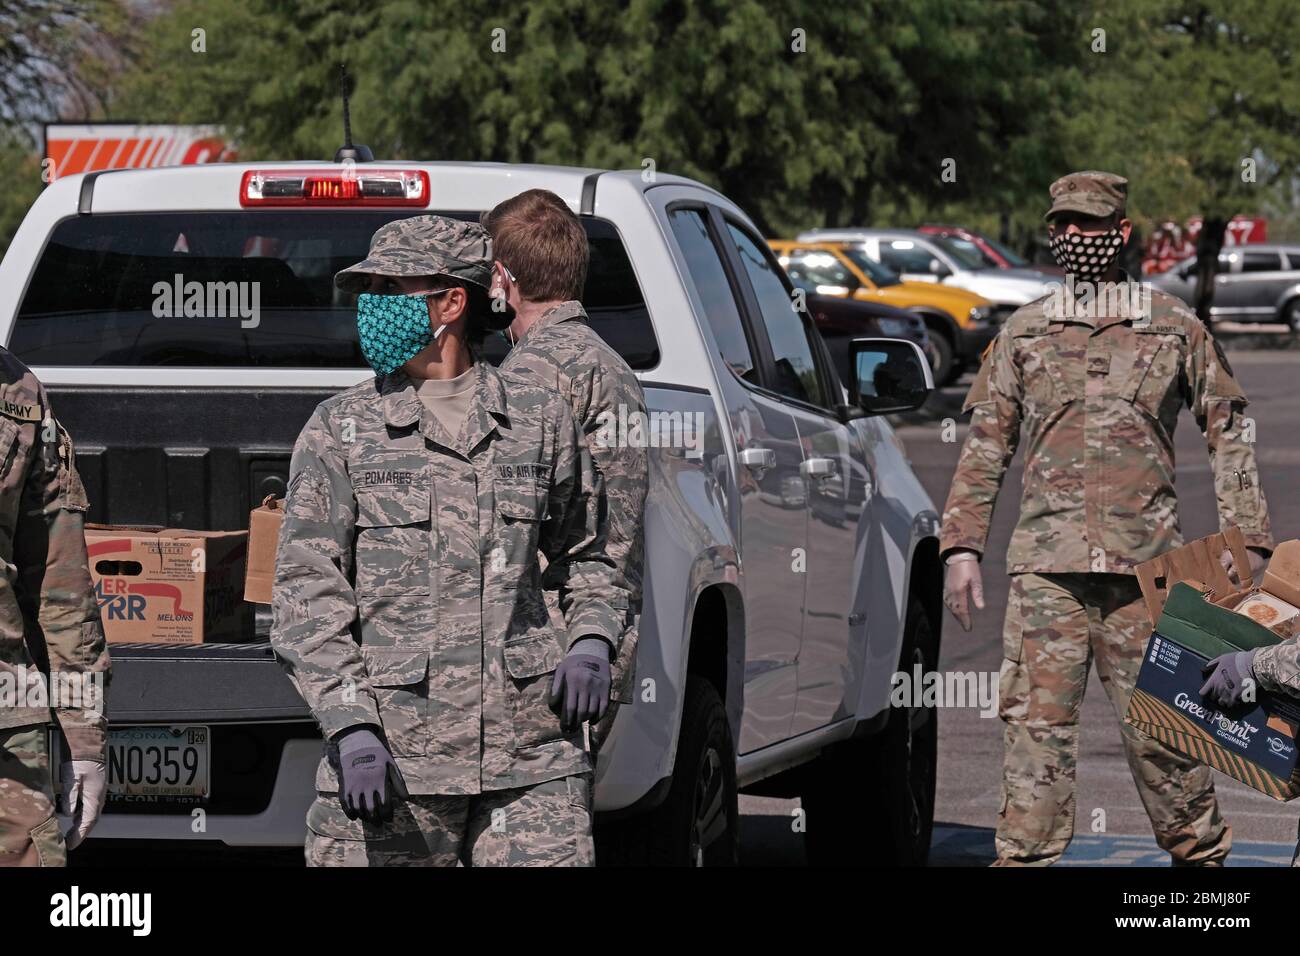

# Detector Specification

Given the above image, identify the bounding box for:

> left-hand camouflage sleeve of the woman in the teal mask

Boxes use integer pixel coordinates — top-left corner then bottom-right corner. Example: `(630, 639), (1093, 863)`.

(270, 408), (380, 739)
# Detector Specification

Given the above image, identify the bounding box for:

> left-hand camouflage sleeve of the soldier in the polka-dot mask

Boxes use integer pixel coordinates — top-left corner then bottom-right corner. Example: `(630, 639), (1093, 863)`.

(939, 328), (1023, 558)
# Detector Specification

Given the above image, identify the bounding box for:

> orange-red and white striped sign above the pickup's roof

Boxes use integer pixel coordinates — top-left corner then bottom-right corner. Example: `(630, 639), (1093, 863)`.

(46, 122), (235, 179)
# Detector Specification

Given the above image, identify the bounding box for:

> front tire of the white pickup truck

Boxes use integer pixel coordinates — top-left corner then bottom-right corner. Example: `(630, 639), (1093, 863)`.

(802, 598), (939, 866)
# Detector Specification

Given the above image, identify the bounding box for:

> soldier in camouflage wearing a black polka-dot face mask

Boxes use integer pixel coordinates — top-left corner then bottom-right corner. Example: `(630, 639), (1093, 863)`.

(941, 172), (1273, 865)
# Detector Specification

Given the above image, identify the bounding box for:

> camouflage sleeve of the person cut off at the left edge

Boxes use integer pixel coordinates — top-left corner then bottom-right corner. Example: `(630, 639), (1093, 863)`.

(14, 389), (109, 762)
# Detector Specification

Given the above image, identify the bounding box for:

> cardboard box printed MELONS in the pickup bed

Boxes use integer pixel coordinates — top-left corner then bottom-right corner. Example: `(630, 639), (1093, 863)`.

(86, 524), (252, 644)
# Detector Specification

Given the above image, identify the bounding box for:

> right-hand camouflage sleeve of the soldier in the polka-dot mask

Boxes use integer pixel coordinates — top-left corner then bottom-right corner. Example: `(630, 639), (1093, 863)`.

(1186, 320), (1273, 551)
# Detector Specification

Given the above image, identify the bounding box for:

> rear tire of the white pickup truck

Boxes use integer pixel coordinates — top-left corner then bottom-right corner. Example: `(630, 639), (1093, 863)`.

(595, 675), (740, 866)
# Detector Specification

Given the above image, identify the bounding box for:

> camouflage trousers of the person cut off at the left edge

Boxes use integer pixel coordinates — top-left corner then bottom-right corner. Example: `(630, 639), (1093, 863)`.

(0, 723), (68, 866)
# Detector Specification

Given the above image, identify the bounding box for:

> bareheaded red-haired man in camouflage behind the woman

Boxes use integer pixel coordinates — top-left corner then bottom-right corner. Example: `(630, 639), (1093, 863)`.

(482, 189), (647, 745)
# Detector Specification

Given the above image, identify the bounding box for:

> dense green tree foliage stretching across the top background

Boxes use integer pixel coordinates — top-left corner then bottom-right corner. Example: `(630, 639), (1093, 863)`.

(0, 0), (1300, 273)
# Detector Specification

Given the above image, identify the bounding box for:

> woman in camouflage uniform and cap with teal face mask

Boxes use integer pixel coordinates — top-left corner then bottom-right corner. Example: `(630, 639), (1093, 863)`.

(272, 216), (627, 865)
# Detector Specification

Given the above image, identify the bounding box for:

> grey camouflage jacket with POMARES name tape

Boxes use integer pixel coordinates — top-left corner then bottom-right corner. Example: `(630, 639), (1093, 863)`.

(272, 362), (627, 795)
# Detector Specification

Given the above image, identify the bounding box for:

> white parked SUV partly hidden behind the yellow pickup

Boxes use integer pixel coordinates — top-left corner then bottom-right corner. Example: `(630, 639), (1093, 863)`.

(798, 229), (1060, 308)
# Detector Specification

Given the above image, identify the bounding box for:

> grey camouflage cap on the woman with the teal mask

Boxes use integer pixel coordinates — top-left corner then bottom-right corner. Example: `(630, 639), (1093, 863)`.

(334, 216), (491, 293)
